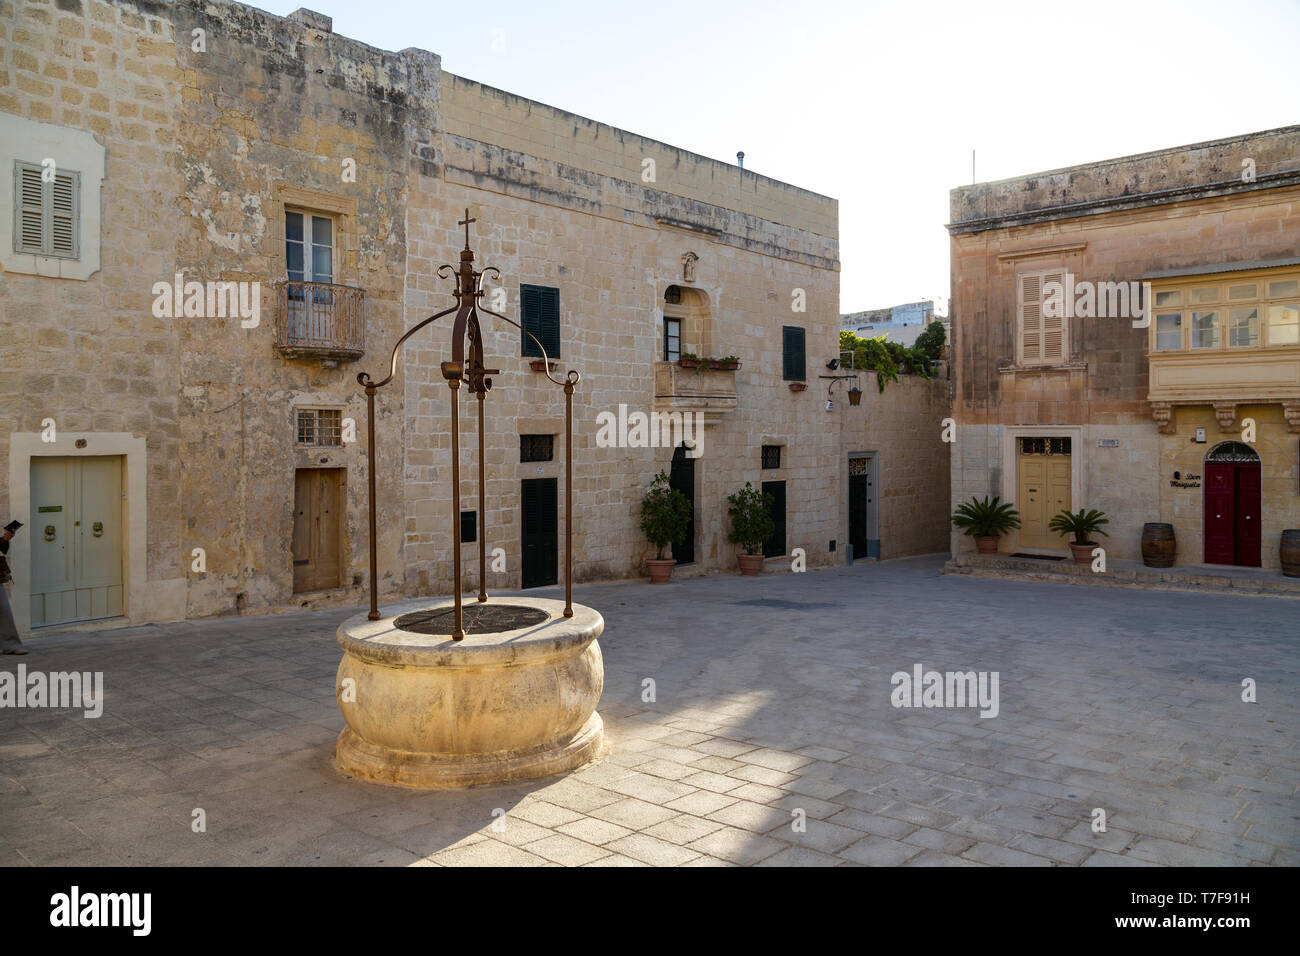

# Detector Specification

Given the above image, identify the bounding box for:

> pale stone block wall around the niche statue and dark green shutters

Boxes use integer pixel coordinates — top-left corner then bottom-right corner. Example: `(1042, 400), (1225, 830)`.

(404, 74), (842, 589)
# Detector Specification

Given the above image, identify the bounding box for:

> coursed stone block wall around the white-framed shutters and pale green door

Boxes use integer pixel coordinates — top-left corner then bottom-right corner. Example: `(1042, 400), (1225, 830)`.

(0, 0), (183, 624)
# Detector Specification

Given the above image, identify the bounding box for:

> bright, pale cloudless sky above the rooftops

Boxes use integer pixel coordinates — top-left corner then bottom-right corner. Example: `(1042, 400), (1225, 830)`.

(263, 0), (1300, 312)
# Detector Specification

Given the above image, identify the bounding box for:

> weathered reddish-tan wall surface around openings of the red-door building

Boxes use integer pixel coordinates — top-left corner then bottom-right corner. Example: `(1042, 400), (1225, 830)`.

(950, 127), (1300, 567)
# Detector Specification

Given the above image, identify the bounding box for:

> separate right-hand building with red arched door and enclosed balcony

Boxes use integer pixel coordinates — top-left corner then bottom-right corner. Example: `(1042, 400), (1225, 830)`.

(948, 126), (1300, 570)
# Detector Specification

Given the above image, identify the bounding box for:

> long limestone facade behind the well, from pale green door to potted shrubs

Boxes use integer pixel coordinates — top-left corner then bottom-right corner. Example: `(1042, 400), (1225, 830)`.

(0, 0), (948, 642)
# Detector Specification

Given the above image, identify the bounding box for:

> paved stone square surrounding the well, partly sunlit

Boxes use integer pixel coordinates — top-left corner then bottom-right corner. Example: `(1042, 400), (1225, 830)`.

(0, 557), (1300, 866)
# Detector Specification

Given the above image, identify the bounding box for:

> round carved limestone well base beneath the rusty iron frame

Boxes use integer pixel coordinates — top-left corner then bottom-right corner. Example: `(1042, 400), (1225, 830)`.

(335, 597), (605, 788)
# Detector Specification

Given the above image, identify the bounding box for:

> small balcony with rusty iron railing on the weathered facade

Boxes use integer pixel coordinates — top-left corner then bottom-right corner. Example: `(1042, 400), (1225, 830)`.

(276, 281), (365, 362)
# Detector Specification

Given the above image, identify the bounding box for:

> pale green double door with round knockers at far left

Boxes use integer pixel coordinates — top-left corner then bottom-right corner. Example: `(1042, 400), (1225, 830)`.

(27, 457), (122, 627)
